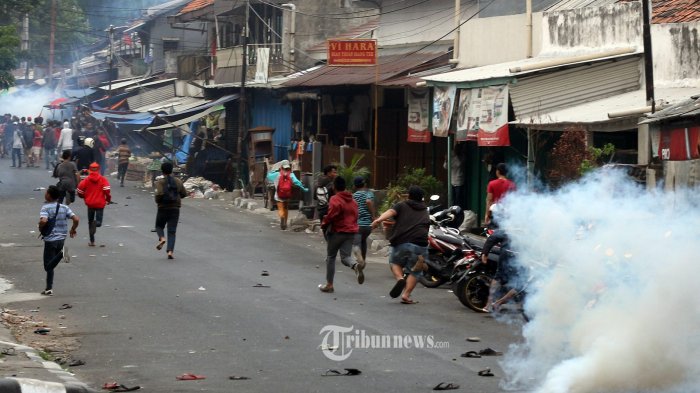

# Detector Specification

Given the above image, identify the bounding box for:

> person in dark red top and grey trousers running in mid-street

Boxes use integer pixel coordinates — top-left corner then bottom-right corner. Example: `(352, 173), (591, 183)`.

(318, 176), (365, 293)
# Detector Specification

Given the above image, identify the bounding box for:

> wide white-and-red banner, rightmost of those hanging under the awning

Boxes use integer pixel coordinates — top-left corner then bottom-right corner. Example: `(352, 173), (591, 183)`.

(456, 85), (510, 146)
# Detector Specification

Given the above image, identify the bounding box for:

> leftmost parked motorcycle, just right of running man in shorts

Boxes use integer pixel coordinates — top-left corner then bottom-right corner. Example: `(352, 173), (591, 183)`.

(418, 204), (473, 288)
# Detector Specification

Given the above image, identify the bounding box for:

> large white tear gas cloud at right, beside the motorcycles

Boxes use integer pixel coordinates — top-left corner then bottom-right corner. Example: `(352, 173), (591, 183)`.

(500, 170), (700, 393)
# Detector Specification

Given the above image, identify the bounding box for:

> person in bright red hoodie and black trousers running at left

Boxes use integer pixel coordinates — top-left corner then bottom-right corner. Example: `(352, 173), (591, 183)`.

(77, 162), (112, 247)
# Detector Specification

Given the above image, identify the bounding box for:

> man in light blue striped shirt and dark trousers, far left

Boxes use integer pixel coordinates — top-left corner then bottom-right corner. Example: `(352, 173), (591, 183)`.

(39, 186), (80, 296)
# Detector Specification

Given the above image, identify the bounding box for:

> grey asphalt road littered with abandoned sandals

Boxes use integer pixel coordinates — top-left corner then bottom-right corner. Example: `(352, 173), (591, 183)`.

(0, 159), (519, 392)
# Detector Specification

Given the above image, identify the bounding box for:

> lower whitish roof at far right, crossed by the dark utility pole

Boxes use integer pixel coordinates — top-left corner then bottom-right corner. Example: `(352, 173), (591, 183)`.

(510, 88), (700, 129)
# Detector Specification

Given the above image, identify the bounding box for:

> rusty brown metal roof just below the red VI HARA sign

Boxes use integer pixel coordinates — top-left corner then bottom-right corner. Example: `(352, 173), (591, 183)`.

(284, 53), (444, 87)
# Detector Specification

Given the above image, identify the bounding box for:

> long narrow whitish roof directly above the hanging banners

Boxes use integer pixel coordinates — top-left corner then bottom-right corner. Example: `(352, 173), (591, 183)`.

(423, 50), (639, 85)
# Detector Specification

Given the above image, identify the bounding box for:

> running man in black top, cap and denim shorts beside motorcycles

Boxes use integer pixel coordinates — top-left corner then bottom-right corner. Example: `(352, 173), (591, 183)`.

(372, 186), (430, 304)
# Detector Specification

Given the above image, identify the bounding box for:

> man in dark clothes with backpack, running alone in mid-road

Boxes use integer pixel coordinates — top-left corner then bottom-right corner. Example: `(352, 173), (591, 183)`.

(155, 162), (187, 259)
